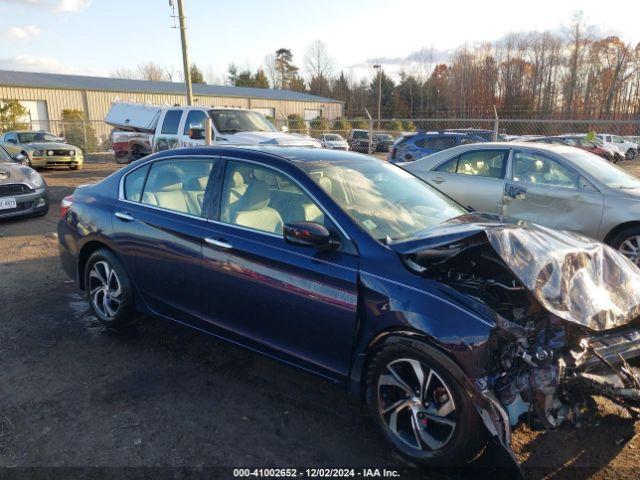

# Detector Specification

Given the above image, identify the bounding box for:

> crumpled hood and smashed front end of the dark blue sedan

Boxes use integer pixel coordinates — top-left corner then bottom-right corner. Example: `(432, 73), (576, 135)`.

(391, 214), (640, 458)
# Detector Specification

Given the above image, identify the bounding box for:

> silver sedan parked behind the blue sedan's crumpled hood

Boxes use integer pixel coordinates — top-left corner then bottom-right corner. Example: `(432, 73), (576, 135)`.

(400, 142), (640, 266)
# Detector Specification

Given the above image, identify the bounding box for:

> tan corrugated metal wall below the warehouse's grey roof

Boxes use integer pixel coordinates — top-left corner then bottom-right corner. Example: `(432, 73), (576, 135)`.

(0, 86), (342, 121)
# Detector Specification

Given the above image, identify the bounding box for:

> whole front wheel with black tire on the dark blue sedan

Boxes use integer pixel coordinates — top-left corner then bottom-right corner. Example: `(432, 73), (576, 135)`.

(366, 341), (486, 467)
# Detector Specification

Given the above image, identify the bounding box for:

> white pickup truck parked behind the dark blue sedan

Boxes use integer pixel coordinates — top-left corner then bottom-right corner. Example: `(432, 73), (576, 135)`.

(105, 102), (322, 163)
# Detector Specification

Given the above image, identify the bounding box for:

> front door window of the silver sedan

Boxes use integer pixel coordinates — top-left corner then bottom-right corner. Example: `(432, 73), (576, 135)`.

(513, 152), (580, 189)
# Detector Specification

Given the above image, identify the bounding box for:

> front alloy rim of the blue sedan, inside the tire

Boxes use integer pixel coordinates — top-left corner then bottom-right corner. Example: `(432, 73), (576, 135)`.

(378, 358), (457, 452)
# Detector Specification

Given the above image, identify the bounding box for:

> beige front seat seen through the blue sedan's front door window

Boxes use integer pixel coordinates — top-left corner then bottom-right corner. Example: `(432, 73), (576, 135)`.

(230, 180), (282, 233)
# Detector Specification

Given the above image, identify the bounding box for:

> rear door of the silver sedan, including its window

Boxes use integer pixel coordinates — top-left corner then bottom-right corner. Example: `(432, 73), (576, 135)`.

(425, 149), (509, 214)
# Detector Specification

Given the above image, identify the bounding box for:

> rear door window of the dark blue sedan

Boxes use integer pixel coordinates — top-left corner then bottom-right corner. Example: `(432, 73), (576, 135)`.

(139, 159), (214, 217)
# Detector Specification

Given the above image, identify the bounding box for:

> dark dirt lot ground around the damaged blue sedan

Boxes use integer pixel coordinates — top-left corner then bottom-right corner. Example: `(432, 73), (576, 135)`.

(0, 156), (640, 479)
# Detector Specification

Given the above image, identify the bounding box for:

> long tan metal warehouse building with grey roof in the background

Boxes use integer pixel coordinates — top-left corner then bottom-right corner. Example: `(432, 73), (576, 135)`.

(0, 70), (343, 130)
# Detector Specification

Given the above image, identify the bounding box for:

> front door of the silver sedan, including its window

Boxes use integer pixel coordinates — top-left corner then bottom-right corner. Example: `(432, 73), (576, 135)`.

(503, 149), (604, 237)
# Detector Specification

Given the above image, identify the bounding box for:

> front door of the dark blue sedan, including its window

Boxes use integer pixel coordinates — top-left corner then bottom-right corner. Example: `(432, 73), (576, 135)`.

(202, 160), (358, 378)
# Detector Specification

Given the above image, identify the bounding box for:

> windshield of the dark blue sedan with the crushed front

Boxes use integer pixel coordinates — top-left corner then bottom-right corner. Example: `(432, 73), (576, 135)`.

(300, 157), (466, 242)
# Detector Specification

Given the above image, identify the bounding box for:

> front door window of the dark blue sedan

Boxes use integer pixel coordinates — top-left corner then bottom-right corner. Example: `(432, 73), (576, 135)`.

(220, 161), (335, 235)
